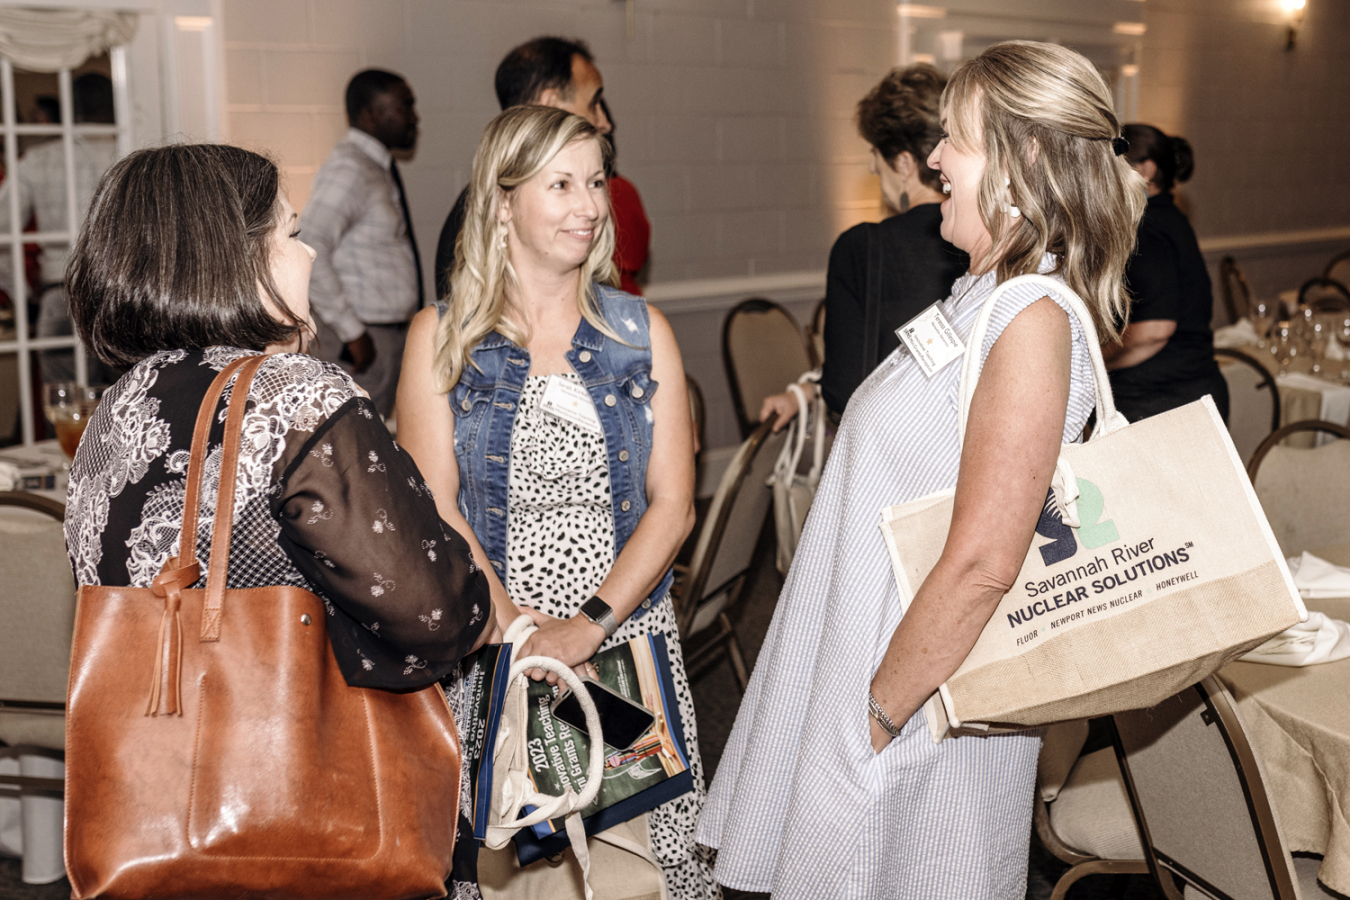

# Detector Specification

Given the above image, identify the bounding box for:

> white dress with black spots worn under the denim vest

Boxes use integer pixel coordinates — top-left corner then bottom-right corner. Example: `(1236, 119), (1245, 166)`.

(506, 372), (721, 900)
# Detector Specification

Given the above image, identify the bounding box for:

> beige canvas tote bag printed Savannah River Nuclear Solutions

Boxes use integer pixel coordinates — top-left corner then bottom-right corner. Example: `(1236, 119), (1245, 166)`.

(882, 275), (1307, 741)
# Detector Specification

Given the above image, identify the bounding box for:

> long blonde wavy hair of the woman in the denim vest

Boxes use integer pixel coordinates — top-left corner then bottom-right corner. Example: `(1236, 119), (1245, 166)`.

(436, 107), (620, 393)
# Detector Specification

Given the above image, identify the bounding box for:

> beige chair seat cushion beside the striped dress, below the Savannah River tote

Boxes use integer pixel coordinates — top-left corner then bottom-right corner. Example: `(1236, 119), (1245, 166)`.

(1050, 748), (1143, 860)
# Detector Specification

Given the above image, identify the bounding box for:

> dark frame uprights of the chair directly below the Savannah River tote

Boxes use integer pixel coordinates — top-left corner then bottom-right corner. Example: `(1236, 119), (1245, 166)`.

(1111, 675), (1299, 900)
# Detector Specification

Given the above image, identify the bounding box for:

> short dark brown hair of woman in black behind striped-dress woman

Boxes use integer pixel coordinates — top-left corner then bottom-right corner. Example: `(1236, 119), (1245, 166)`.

(857, 62), (946, 190)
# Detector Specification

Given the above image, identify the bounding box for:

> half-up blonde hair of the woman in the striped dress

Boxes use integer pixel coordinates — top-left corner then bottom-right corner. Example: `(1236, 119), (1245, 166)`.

(942, 40), (1148, 340)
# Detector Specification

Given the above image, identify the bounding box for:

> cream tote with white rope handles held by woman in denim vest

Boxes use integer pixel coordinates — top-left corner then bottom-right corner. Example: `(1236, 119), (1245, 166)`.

(478, 615), (667, 900)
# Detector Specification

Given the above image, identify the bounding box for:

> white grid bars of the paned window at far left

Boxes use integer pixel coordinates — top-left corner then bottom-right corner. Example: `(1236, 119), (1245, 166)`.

(0, 47), (131, 445)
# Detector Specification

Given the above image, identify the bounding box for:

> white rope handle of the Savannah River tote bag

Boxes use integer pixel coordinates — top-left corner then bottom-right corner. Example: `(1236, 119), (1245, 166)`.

(957, 275), (1130, 528)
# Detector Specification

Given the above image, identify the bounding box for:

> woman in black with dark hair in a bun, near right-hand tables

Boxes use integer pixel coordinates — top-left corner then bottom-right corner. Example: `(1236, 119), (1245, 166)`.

(1102, 124), (1229, 422)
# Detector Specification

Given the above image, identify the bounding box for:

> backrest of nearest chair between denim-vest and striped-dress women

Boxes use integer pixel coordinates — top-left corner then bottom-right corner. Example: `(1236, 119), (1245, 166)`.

(676, 422), (787, 641)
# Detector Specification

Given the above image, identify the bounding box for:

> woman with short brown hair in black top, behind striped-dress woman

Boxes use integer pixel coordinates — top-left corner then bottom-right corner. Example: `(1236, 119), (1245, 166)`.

(760, 63), (969, 430)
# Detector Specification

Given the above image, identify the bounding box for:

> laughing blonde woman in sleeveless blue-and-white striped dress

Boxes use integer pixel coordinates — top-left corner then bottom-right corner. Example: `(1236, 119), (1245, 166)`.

(698, 40), (1143, 900)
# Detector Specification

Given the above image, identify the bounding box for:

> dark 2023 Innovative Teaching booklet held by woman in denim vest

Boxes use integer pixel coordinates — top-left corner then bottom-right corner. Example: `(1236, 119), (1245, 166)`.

(462, 634), (694, 866)
